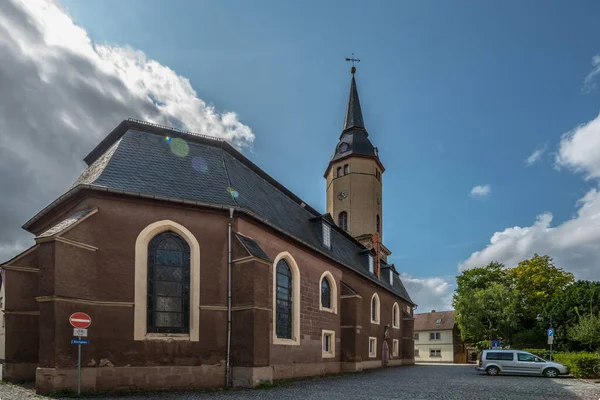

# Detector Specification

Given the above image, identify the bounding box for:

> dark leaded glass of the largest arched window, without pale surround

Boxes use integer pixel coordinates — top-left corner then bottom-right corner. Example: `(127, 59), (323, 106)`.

(147, 231), (190, 333)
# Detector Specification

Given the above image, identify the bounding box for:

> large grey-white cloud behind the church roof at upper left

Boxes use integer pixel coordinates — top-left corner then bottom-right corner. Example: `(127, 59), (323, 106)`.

(0, 0), (254, 262)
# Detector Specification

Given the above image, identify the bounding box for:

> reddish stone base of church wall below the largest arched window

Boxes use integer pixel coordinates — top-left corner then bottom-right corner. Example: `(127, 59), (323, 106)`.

(35, 364), (225, 394)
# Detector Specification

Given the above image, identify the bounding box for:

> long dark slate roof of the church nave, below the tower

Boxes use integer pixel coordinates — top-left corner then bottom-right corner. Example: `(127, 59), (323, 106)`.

(24, 120), (414, 304)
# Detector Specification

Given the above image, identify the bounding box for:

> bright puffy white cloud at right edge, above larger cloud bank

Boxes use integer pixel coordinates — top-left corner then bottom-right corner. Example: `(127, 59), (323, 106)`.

(556, 111), (600, 179)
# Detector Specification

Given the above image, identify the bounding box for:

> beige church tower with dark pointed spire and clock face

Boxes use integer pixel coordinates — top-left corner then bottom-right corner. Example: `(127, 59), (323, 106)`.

(324, 66), (390, 260)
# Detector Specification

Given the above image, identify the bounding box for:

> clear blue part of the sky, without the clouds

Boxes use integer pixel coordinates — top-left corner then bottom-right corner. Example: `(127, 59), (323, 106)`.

(3, 0), (600, 308)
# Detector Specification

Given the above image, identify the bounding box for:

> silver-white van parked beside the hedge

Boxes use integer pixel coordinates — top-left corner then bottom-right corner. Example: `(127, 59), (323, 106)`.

(477, 350), (569, 378)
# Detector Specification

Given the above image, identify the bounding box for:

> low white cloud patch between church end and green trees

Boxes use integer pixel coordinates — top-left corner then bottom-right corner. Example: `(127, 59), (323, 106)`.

(401, 273), (455, 312)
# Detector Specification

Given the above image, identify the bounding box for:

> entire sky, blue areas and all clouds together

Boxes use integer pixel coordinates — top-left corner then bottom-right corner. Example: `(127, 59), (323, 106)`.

(0, 0), (600, 312)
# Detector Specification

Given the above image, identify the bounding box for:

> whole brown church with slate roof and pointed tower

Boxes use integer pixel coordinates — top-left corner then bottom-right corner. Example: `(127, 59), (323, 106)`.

(2, 67), (415, 394)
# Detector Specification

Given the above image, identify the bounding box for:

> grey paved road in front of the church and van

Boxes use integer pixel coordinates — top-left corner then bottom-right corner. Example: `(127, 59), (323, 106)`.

(0, 365), (600, 400)
